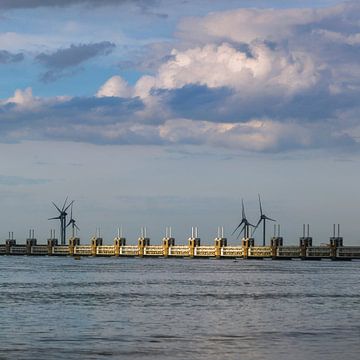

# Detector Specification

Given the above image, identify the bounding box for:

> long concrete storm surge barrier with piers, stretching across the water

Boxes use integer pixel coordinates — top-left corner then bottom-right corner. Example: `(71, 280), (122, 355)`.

(0, 236), (360, 260)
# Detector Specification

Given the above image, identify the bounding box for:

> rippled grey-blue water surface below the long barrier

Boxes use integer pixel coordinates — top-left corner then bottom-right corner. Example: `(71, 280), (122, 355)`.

(0, 256), (360, 360)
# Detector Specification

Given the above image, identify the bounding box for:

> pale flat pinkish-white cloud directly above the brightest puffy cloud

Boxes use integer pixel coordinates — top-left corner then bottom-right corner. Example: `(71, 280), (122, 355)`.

(179, 5), (345, 43)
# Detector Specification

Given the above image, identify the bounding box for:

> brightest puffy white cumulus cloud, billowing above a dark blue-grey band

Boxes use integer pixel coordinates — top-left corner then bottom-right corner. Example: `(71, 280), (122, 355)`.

(156, 42), (318, 94)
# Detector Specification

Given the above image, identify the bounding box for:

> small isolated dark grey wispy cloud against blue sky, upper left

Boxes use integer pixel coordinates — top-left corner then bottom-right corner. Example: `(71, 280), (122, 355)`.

(36, 41), (115, 81)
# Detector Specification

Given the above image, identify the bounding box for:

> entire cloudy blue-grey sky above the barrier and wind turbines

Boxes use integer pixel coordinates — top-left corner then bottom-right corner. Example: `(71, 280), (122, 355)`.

(0, 0), (360, 245)
